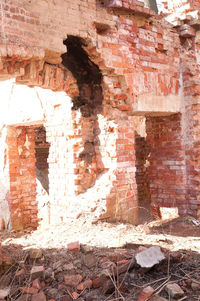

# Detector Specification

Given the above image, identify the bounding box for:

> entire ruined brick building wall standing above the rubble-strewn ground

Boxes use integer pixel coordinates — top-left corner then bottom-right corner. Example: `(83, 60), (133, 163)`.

(0, 0), (200, 240)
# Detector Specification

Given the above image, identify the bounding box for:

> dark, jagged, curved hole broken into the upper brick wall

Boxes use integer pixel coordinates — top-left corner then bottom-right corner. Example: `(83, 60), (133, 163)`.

(62, 36), (103, 117)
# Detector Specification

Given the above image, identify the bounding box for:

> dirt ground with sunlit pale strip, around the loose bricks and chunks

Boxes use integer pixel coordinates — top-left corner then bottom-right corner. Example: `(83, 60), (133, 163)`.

(0, 216), (200, 301)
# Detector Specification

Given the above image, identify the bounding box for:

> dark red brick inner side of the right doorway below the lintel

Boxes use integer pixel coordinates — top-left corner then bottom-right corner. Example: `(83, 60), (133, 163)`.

(146, 114), (188, 214)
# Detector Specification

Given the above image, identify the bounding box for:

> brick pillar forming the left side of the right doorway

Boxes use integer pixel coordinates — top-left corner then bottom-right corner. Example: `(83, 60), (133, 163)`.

(104, 116), (138, 224)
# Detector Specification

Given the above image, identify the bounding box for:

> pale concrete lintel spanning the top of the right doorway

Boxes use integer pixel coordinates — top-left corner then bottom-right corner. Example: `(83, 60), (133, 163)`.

(132, 94), (181, 116)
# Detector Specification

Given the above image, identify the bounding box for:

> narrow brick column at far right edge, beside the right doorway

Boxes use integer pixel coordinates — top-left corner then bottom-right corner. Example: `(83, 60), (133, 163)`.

(182, 44), (200, 217)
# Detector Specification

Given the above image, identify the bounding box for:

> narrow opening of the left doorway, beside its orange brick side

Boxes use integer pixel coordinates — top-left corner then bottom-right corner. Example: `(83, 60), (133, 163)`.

(35, 126), (49, 195)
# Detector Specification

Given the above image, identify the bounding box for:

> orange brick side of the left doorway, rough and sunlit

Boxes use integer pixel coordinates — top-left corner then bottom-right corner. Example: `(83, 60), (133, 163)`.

(7, 127), (38, 230)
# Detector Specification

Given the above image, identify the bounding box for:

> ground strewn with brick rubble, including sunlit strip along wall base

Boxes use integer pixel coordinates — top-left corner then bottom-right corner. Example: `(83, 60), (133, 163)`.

(0, 214), (200, 301)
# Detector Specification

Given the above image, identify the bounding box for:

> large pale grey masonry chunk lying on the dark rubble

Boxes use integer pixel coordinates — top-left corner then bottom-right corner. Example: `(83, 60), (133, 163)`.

(135, 246), (165, 268)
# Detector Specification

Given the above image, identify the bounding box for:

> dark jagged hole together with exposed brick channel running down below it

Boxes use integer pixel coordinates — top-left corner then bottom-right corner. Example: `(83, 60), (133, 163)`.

(62, 35), (103, 194)
